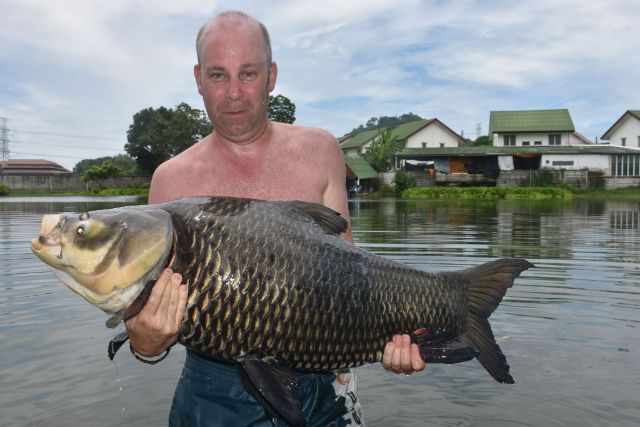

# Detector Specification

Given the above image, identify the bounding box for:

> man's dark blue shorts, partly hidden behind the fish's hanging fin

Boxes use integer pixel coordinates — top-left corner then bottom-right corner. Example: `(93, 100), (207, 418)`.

(169, 350), (358, 427)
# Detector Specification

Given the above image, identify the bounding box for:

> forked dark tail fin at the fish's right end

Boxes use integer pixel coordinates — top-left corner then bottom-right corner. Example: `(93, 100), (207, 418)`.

(461, 259), (533, 384)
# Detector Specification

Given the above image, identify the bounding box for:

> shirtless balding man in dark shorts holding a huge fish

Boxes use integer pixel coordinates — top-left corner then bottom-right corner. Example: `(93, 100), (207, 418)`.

(126, 12), (424, 426)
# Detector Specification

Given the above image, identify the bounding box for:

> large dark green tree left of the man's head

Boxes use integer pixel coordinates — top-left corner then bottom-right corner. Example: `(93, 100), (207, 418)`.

(124, 102), (213, 175)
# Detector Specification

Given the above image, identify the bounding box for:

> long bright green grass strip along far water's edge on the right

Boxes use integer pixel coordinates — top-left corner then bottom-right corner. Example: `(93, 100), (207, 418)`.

(401, 187), (575, 200)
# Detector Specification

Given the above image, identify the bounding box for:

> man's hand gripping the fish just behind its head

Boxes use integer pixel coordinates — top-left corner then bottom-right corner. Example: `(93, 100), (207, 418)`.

(125, 268), (187, 356)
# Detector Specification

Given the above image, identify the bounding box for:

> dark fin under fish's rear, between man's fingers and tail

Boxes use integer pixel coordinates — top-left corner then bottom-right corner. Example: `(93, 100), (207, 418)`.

(411, 329), (478, 364)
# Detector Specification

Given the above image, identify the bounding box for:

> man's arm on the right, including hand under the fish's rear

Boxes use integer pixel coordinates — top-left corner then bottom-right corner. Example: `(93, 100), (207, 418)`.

(322, 133), (425, 374)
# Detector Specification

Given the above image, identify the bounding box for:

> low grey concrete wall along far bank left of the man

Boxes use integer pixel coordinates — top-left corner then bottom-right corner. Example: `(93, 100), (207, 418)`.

(0, 174), (151, 191)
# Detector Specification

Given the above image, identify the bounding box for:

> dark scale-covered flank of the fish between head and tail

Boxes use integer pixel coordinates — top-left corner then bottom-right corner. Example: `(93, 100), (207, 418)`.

(166, 199), (459, 369)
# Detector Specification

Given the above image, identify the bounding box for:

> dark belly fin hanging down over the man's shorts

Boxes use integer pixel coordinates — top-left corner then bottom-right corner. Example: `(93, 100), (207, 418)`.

(238, 357), (307, 426)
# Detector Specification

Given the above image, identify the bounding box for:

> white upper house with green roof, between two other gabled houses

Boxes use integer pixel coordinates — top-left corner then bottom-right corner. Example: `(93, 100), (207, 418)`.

(489, 109), (592, 147)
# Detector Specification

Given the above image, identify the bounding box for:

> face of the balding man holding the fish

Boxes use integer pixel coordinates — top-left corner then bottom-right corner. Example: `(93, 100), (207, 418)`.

(195, 23), (277, 142)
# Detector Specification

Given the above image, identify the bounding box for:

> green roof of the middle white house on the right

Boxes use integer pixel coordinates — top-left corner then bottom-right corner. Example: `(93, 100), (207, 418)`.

(489, 109), (575, 135)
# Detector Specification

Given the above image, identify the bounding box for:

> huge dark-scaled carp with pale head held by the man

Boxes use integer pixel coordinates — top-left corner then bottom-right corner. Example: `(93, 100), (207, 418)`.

(31, 197), (533, 425)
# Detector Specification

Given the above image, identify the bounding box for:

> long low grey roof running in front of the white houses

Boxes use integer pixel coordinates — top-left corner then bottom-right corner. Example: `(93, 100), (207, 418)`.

(396, 144), (640, 157)
